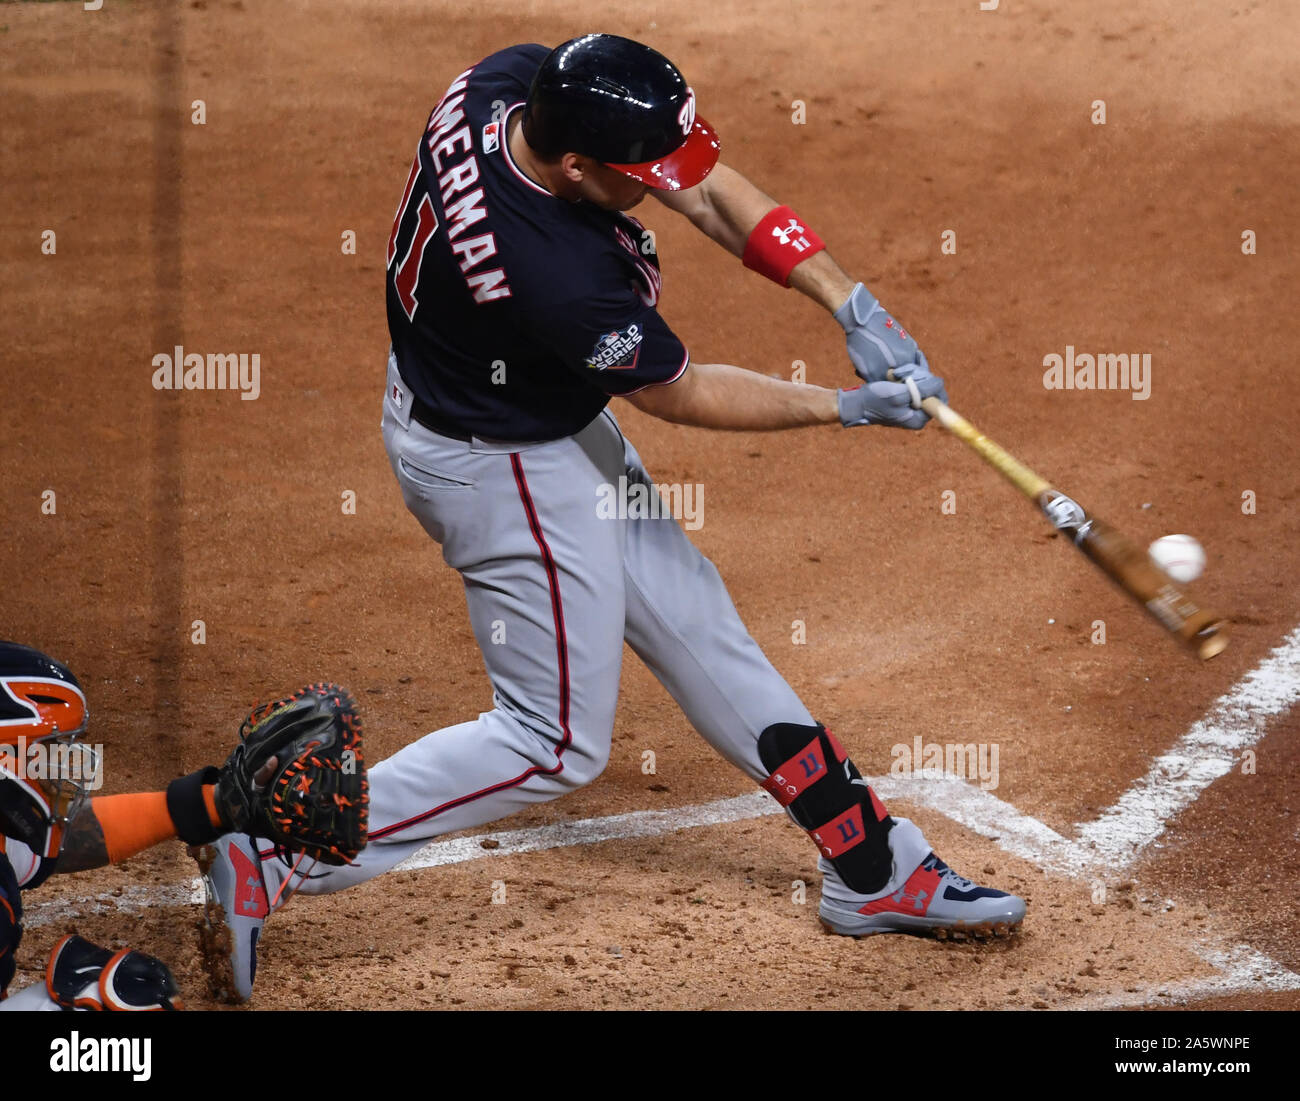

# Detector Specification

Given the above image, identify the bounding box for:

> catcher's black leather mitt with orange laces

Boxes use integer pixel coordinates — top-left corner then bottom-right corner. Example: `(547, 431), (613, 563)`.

(216, 684), (371, 864)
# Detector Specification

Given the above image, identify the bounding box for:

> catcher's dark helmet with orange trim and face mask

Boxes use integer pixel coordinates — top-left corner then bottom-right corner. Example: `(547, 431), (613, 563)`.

(0, 642), (99, 857)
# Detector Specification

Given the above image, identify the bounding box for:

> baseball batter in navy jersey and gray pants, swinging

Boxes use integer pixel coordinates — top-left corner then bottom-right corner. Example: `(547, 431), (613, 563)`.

(197, 35), (1024, 998)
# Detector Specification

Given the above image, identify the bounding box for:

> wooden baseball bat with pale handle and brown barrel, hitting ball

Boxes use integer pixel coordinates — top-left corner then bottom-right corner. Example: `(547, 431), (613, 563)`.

(920, 398), (1227, 660)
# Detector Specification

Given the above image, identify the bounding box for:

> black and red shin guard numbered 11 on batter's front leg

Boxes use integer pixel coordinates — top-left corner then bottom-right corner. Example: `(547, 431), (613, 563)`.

(758, 723), (894, 894)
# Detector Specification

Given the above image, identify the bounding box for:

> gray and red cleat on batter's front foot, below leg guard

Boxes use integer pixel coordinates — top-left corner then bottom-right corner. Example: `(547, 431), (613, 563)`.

(818, 818), (1024, 940)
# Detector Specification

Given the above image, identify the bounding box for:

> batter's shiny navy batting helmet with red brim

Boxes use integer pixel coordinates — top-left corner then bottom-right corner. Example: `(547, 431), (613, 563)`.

(524, 34), (720, 191)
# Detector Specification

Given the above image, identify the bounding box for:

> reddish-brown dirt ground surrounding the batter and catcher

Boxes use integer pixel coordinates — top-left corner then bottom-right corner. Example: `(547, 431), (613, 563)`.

(0, 0), (1300, 1009)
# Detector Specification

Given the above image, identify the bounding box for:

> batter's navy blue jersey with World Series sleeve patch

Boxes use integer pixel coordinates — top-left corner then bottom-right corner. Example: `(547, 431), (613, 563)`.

(387, 45), (689, 441)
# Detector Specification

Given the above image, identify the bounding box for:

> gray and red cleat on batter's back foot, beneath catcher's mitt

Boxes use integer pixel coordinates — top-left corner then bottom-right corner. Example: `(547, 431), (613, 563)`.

(190, 833), (270, 1004)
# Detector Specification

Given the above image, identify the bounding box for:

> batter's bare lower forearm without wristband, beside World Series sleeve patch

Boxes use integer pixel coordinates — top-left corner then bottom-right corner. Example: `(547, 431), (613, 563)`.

(628, 363), (840, 432)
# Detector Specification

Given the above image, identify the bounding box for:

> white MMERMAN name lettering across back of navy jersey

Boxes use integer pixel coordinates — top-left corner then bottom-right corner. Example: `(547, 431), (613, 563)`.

(413, 70), (511, 303)
